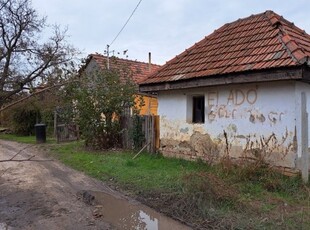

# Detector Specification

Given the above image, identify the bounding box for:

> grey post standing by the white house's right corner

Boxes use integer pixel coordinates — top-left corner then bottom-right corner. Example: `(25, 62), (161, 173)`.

(301, 92), (309, 183)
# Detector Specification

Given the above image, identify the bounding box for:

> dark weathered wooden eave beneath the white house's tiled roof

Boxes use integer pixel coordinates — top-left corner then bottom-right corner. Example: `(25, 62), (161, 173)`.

(139, 65), (310, 92)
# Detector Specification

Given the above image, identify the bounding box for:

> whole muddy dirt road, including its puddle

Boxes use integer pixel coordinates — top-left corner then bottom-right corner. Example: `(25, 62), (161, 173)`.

(0, 140), (189, 230)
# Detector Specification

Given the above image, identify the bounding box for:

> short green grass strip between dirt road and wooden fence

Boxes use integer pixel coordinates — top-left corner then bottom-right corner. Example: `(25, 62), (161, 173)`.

(53, 143), (207, 192)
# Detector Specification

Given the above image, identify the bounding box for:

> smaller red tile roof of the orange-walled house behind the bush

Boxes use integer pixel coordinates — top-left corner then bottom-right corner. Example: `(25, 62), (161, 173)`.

(84, 54), (160, 84)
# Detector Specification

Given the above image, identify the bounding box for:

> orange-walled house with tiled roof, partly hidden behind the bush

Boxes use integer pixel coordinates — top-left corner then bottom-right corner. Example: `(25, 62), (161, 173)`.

(80, 54), (160, 115)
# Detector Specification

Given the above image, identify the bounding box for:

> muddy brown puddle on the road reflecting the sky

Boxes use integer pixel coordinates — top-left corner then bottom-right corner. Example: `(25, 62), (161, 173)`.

(90, 191), (191, 230)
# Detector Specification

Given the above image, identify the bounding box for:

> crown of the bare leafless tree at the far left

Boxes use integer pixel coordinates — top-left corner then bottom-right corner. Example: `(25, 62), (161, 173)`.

(0, 0), (76, 108)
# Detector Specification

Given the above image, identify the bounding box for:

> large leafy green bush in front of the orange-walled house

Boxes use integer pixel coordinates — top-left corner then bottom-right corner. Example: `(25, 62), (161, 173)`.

(72, 70), (136, 149)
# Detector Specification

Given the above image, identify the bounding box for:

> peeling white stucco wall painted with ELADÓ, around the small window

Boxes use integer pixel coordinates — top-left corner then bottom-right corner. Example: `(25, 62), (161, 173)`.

(158, 81), (310, 168)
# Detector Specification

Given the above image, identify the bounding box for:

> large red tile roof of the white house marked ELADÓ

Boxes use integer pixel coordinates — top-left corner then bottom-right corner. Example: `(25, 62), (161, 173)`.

(142, 11), (310, 85)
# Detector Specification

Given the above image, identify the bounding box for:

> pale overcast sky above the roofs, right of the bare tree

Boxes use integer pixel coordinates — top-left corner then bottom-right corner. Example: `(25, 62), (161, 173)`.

(32, 0), (310, 64)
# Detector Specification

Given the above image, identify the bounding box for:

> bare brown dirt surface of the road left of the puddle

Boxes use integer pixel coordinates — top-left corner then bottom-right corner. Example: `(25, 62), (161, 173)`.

(0, 140), (112, 229)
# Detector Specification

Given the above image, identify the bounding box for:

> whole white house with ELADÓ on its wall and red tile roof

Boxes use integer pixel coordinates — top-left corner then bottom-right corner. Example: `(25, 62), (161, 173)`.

(140, 11), (310, 169)
